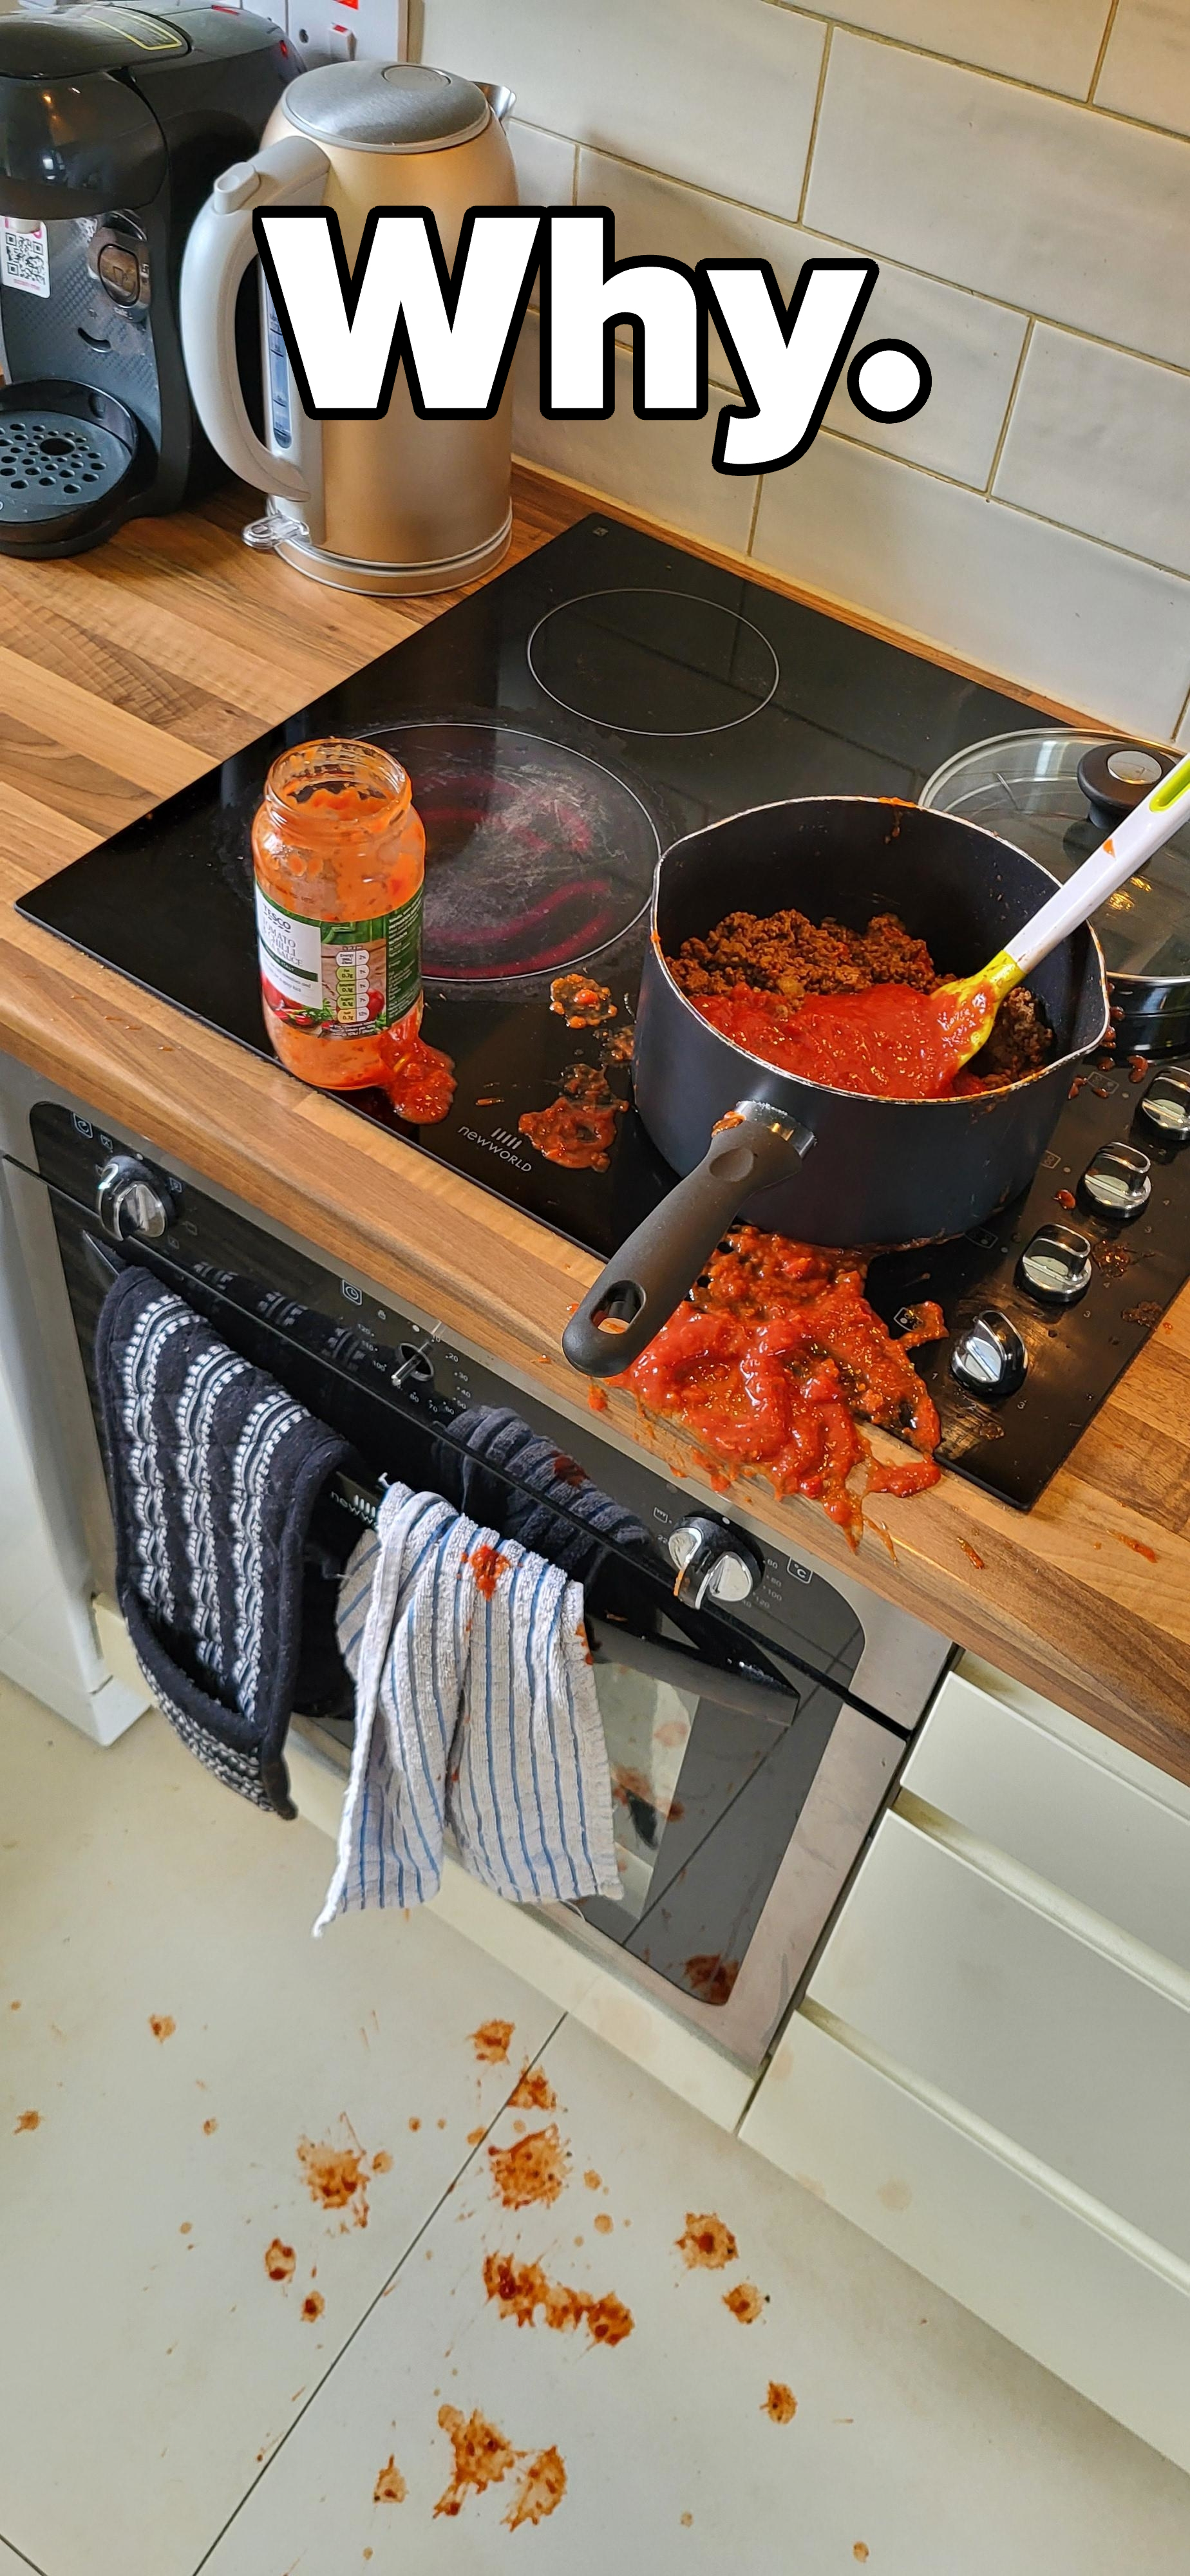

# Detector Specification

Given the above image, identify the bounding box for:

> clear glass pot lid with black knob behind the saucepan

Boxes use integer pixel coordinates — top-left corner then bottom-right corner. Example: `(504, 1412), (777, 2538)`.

(920, 726), (1190, 984)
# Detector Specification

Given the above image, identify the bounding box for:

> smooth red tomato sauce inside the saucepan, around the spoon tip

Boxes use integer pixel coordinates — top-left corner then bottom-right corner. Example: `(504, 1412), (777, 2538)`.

(690, 984), (992, 1100)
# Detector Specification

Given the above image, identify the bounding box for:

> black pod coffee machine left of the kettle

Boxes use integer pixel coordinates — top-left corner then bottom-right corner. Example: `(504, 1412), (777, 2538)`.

(0, 0), (301, 556)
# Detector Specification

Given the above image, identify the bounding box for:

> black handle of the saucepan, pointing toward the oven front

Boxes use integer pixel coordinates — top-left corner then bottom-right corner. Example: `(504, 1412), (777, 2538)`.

(562, 1100), (814, 1378)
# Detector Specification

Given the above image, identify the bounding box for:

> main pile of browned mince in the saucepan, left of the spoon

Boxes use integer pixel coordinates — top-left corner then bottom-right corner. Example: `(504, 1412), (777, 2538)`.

(670, 912), (940, 1002)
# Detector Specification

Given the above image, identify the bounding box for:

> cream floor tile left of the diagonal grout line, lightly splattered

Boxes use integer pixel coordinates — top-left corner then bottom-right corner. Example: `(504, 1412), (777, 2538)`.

(0, 1685), (556, 2576)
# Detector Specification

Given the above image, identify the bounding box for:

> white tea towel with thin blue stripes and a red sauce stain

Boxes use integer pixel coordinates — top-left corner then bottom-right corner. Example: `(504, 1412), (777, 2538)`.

(314, 1484), (621, 1932)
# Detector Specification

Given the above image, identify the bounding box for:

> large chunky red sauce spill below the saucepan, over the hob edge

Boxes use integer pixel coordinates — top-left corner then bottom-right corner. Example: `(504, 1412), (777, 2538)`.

(613, 1226), (945, 1546)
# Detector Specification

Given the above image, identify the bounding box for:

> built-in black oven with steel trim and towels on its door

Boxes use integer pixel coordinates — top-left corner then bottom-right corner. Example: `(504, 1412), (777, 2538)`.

(0, 1066), (950, 2071)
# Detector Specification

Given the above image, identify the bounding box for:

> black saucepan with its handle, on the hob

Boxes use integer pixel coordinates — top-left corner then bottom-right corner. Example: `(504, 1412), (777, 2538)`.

(562, 796), (1108, 1378)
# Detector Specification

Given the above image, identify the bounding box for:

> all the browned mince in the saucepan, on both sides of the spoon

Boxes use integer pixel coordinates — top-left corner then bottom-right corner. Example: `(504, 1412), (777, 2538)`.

(670, 912), (1053, 1084)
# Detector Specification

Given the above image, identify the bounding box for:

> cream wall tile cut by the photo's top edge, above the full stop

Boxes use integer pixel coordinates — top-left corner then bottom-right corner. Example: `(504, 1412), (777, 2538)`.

(793, 0), (1110, 98)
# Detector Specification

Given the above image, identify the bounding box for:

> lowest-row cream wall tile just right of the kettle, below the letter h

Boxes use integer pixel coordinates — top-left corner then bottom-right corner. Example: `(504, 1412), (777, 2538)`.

(513, 314), (757, 554)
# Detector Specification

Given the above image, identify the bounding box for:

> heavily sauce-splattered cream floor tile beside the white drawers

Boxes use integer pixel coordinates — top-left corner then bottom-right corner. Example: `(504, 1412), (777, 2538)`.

(206, 2025), (1190, 2576)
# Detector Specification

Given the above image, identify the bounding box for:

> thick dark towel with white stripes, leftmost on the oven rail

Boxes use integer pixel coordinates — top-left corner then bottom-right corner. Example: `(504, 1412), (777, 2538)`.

(95, 1262), (350, 1816)
